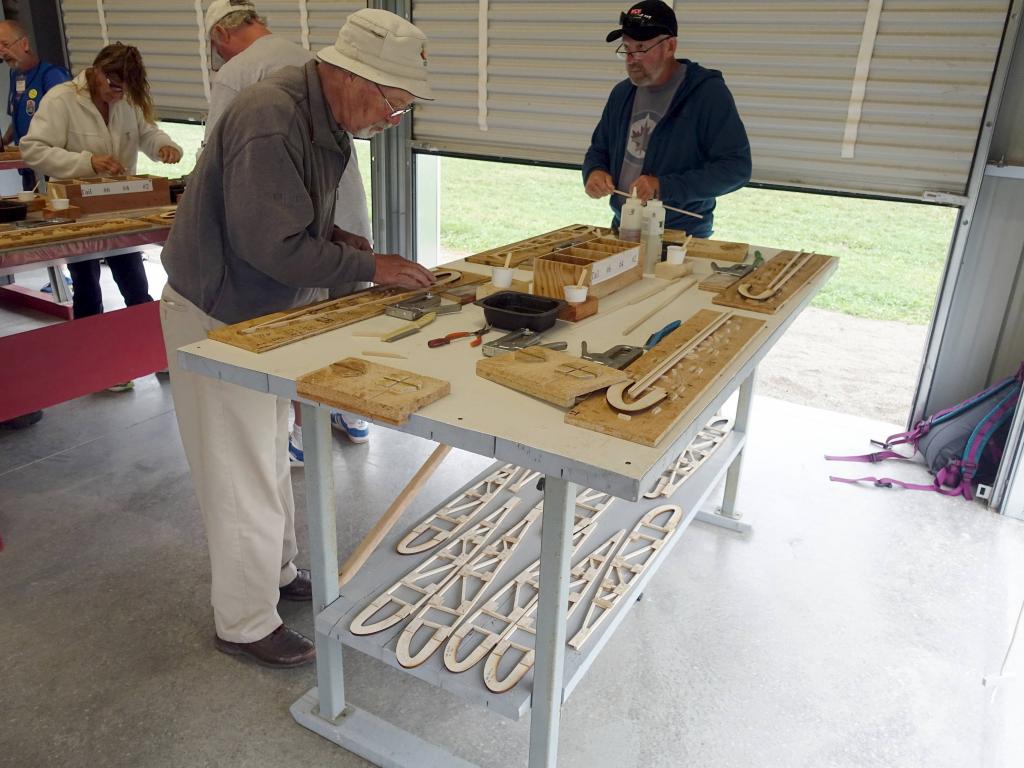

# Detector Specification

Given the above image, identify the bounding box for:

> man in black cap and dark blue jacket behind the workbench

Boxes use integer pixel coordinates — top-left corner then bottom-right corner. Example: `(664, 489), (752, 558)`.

(583, 0), (751, 238)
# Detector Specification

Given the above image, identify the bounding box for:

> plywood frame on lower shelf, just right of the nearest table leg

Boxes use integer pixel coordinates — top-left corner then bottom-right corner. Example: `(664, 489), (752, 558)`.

(569, 504), (683, 650)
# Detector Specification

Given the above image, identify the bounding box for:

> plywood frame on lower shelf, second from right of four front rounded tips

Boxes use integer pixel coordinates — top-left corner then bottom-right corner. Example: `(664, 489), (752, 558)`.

(444, 488), (614, 675)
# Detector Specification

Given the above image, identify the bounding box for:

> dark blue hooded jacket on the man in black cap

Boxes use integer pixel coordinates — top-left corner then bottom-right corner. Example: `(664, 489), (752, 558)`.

(583, 58), (751, 238)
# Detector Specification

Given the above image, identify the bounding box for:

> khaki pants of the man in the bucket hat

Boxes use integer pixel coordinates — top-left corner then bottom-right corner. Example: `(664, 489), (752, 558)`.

(160, 286), (298, 643)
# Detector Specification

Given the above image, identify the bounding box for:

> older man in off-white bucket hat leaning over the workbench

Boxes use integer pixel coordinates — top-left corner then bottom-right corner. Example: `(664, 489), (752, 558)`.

(161, 9), (433, 668)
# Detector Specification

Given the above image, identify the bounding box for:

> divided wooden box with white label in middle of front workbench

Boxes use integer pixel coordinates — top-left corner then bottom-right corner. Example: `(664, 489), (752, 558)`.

(534, 238), (643, 299)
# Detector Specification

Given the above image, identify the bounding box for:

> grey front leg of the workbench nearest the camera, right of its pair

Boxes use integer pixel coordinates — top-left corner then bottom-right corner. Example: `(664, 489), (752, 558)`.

(529, 475), (577, 768)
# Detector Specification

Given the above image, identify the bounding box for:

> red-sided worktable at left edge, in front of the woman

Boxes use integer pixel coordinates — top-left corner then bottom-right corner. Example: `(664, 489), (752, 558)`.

(0, 208), (170, 421)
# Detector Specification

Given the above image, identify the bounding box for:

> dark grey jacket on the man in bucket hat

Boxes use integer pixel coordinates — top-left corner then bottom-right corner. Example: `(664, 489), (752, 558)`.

(157, 61), (375, 324)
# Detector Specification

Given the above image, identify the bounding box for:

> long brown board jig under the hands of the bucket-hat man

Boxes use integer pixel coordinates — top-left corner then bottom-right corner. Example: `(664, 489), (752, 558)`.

(208, 269), (487, 353)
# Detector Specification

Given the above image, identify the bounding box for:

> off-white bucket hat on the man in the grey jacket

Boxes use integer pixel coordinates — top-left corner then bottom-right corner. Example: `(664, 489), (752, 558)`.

(317, 8), (434, 101)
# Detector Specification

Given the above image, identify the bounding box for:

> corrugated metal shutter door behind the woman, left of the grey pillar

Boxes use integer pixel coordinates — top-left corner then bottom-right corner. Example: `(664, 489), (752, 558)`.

(60, 0), (366, 120)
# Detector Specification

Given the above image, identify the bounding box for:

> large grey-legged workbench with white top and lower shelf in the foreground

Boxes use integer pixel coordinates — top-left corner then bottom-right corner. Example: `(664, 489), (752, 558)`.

(178, 248), (835, 768)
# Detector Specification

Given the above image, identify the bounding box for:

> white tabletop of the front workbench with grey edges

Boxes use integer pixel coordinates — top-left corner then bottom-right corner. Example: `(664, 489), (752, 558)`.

(179, 256), (835, 500)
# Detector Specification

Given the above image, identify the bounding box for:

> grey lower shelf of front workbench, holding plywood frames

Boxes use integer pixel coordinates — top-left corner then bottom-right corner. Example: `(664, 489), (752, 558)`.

(316, 430), (745, 720)
